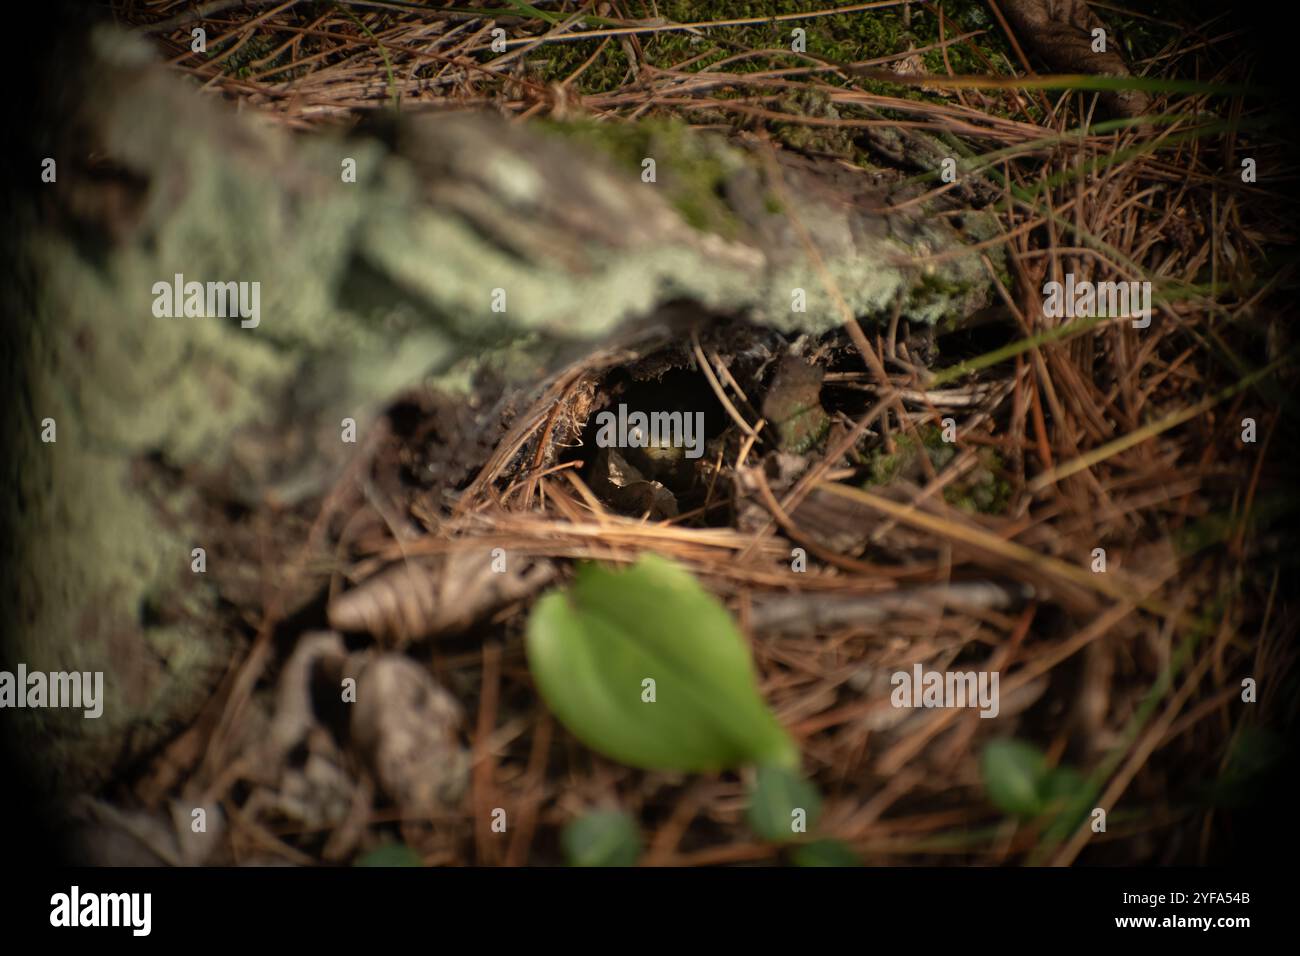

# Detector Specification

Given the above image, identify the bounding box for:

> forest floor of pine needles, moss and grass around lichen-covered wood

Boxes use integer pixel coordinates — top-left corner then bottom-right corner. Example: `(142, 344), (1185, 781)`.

(101, 0), (1300, 865)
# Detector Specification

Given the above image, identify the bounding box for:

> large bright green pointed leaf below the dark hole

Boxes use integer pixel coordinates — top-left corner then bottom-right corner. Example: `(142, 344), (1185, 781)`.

(527, 554), (798, 771)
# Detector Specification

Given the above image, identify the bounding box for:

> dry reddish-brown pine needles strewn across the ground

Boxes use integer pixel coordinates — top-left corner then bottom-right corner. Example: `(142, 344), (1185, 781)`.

(117, 3), (1295, 865)
